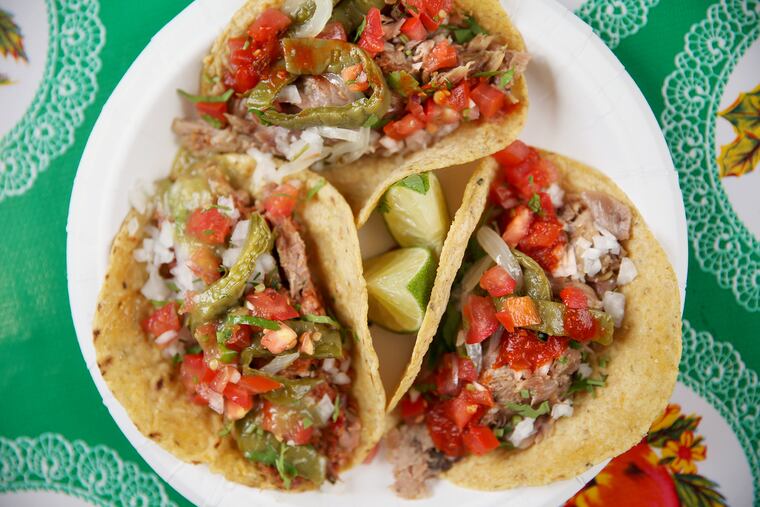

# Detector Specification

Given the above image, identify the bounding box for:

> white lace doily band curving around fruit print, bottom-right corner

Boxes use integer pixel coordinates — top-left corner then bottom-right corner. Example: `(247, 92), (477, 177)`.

(678, 320), (760, 502)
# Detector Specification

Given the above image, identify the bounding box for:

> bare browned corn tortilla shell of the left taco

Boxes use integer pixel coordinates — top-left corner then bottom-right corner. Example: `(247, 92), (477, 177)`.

(93, 160), (385, 489)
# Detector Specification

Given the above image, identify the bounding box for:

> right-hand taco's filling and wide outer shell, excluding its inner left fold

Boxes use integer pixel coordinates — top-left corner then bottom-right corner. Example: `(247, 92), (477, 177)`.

(386, 141), (681, 498)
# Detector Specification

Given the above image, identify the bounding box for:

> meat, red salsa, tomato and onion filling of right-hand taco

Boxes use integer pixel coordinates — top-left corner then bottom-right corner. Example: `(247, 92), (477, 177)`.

(388, 141), (635, 498)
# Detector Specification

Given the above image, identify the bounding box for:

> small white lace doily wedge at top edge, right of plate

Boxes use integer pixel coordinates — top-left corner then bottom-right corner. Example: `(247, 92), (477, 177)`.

(575, 0), (660, 49)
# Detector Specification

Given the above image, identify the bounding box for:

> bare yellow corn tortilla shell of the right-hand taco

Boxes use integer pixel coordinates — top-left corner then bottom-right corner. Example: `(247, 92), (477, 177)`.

(391, 152), (681, 490)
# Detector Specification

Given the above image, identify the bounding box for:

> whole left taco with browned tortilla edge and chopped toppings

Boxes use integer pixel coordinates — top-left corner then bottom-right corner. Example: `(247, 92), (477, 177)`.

(93, 154), (385, 491)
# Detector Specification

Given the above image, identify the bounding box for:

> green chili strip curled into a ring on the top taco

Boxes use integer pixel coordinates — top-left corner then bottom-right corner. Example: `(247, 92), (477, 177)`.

(248, 39), (391, 129)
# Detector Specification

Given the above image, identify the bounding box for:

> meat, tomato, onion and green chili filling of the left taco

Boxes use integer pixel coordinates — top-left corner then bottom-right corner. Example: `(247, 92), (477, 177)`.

(134, 157), (361, 488)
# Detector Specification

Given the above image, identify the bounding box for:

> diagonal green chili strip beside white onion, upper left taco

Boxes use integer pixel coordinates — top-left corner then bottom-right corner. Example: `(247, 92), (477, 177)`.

(190, 213), (272, 328)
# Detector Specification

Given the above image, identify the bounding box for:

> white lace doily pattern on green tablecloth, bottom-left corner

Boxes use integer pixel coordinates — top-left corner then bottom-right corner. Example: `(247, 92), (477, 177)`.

(0, 433), (176, 507)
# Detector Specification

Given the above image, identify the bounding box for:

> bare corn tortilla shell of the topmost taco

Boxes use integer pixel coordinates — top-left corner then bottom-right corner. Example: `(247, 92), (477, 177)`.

(205, 0), (528, 227)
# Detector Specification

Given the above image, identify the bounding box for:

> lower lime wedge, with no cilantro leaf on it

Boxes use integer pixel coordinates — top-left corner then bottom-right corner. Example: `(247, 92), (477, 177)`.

(364, 247), (436, 333)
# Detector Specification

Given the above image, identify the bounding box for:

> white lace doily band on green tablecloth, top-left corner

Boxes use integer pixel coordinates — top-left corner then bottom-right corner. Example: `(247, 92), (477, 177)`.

(0, 0), (105, 201)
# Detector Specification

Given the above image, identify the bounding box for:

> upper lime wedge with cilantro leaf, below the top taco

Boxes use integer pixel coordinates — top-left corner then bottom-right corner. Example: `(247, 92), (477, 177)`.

(380, 173), (451, 256)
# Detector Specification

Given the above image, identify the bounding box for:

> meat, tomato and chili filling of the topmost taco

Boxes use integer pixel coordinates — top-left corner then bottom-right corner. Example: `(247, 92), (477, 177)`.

(174, 0), (529, 181)
